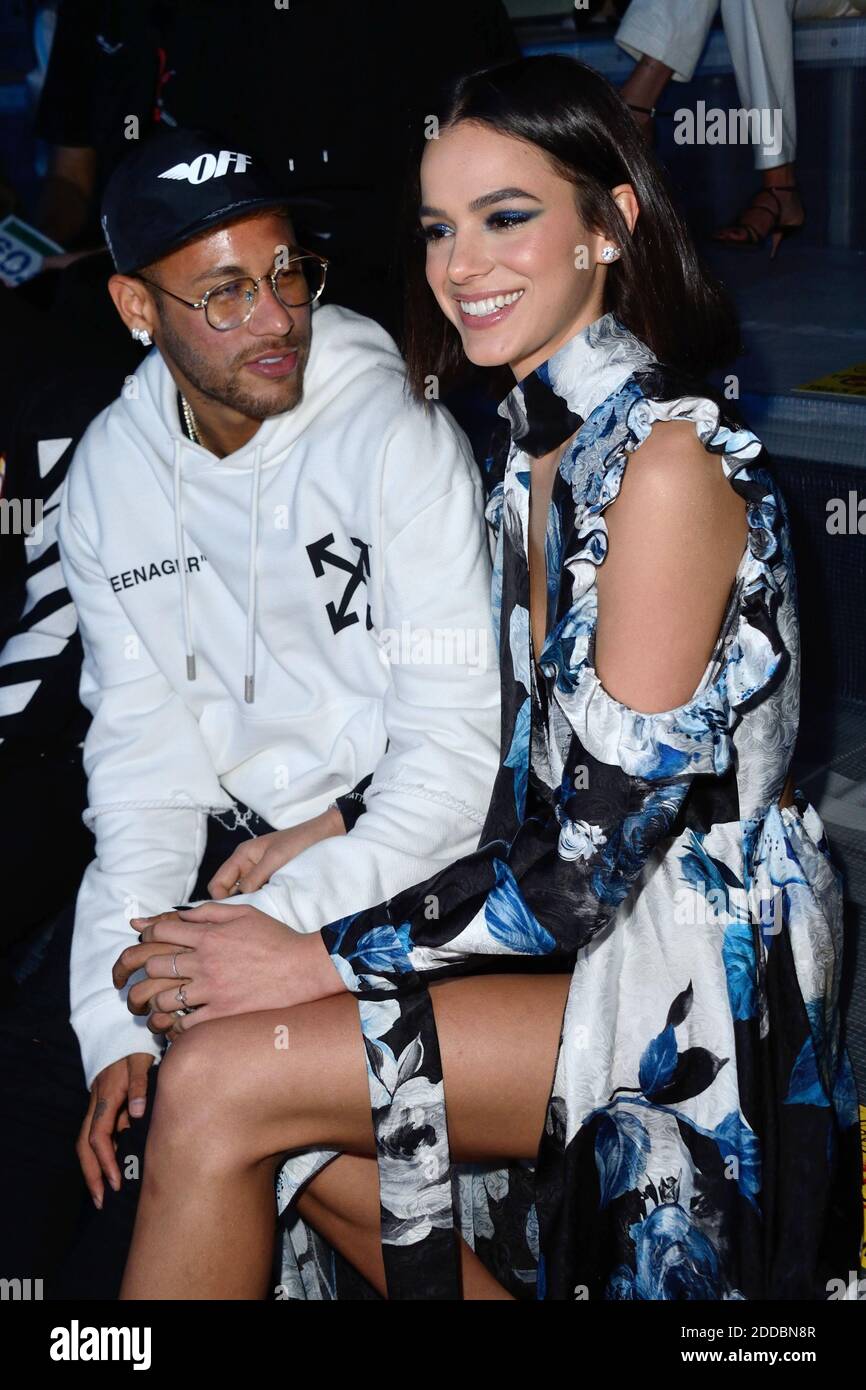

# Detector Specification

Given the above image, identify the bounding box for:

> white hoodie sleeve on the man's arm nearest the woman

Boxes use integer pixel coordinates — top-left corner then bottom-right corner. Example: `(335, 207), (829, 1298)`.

(232, 407), (499, 931)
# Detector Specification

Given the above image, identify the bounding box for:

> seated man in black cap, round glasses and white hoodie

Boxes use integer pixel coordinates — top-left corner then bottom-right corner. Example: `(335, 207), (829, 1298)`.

(42, 131), (498, 1289)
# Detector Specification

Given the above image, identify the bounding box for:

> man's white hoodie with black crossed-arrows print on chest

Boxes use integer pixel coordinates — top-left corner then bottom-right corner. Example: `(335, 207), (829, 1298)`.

(60, 304), (499, 1086)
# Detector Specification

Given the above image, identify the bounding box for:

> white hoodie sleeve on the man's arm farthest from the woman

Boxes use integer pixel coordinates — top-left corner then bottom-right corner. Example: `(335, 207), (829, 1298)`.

(58, 478), (228, 1086)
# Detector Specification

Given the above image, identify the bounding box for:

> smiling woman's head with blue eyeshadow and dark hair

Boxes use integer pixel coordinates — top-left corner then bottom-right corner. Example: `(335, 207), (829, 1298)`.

(405, 61), (738, 400)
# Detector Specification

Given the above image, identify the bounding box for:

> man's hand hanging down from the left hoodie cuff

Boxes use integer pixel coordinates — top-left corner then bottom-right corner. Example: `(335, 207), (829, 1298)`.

(75, 1052), (154, 1211)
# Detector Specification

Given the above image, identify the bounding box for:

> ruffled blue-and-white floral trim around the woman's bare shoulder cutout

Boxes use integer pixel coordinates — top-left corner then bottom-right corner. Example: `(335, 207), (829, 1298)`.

(541, 386), (788, 783)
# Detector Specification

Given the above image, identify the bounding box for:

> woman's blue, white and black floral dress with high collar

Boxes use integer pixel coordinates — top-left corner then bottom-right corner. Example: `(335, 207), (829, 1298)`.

(271, 314), (860, 1300)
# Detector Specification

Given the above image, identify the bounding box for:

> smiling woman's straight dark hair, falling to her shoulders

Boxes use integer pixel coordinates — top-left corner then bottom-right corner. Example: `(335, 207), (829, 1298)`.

(403, 54), (740, 399)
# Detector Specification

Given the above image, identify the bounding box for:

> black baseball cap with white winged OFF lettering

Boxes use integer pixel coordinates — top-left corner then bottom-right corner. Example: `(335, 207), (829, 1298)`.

(100, 128), (322, 275)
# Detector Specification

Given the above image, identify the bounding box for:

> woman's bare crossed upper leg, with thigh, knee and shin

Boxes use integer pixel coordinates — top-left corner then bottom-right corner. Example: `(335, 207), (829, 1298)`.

(121, 974), (569, 1298)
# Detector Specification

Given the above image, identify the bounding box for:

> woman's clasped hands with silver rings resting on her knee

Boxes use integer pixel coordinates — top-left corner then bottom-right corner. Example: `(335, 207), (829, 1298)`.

(113, 902), (345, 1040)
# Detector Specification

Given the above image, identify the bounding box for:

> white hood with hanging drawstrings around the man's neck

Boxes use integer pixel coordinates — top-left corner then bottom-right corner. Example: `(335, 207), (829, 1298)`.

(118, 304), (405, 705)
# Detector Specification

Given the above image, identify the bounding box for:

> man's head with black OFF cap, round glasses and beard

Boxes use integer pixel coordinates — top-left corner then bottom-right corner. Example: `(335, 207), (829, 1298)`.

(100, 131), (327, 456)
